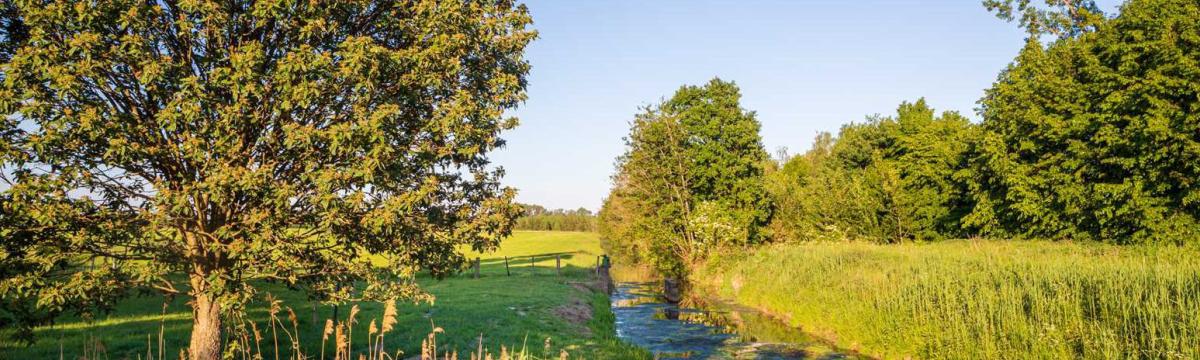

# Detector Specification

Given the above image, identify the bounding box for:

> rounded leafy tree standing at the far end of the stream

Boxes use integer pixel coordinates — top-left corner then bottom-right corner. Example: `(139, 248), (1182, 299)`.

(600, 79), (772, 276)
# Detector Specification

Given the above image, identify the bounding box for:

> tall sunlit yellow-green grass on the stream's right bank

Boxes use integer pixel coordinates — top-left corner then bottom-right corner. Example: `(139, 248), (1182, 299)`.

(692, 240), (1200, 359)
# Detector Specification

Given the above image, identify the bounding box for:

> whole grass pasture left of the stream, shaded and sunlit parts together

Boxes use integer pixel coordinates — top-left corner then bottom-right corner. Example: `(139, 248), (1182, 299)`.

(0, 232), (648, 359)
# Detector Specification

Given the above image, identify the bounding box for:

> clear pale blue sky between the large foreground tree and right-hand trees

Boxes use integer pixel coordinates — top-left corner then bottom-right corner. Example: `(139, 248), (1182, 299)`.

(492, 0), (1116, 211)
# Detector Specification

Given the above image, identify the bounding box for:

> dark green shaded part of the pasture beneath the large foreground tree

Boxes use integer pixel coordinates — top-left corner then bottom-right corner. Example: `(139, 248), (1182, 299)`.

(0, 262), (614, 359)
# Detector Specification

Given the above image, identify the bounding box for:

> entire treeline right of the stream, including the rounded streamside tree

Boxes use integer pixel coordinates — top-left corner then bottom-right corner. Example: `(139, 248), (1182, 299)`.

(599, 0), (1200, 274)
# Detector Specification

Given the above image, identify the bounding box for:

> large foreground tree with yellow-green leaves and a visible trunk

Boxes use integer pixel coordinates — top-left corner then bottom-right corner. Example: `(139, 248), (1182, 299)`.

(0, 0), (535, 359)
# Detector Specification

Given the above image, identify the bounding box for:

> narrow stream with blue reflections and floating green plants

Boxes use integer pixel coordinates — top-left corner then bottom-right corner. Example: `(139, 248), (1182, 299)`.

(612, 282), (853, 359)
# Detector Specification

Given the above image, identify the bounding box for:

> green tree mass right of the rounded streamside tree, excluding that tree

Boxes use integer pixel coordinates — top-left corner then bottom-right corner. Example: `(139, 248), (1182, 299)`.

(767, 0), (1200, 244)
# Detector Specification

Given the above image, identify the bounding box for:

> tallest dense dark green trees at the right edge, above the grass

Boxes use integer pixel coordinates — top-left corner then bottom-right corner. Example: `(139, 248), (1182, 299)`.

(966, 0), (1200, 242)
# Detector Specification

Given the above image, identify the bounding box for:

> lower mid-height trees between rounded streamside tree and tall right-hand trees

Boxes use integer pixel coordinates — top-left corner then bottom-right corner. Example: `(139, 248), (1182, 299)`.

(767, 100), (974, 242)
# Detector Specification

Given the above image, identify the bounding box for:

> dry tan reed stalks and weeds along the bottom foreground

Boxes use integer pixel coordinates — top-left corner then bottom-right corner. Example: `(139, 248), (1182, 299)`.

(39, 274), (650, 360)
